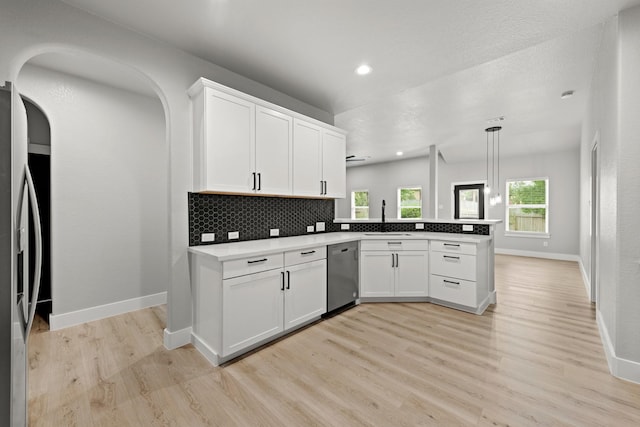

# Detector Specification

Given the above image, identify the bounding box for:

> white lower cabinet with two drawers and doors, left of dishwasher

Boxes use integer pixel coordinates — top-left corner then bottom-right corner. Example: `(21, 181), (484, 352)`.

(190, 246), (327, 365)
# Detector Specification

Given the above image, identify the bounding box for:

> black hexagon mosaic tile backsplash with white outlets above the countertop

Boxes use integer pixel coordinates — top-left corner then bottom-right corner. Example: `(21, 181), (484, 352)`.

(188, 193), (490, 246)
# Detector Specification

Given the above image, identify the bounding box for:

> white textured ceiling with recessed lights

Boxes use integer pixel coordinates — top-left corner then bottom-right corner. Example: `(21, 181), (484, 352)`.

(53, 0), (640, 162)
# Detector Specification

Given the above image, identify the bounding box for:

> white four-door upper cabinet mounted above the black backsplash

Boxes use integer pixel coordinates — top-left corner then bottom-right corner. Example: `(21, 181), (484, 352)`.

(189, 79), (346, 198)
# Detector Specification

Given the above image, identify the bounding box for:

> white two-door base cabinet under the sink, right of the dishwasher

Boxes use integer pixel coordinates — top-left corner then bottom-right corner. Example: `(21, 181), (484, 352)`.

(360, 240), (429, 298)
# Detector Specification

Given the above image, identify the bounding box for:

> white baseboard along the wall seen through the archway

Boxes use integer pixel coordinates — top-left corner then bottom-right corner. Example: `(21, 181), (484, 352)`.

(49, 292), (167, 331)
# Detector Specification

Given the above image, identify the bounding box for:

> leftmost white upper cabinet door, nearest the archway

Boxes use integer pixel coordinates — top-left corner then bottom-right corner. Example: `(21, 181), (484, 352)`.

(205, 88), (255, 193)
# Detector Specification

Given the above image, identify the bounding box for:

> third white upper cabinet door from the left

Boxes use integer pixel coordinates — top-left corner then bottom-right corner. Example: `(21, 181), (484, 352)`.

(293, 119), (322, 196)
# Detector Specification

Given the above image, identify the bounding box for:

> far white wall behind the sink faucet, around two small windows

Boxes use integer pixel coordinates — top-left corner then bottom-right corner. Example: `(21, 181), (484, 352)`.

(336, 157), (432, 218)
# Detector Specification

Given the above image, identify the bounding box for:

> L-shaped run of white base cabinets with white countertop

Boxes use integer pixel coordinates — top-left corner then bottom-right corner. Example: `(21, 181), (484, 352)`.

(189, 220), (498, 365)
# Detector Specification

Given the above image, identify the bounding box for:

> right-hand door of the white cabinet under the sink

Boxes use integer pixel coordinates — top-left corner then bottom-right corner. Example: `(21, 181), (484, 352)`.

(395, 251), (429, 297)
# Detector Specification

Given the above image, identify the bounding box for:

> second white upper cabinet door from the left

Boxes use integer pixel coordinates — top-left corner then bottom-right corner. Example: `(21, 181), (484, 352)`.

(255, 106), (293, 195)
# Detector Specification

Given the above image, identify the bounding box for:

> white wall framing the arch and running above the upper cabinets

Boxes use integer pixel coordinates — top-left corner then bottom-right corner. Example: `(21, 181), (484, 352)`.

(0, 0), (333, 347)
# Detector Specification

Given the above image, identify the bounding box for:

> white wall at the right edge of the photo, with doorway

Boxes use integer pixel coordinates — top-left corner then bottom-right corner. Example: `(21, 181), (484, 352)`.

(580, 7), (640, 382)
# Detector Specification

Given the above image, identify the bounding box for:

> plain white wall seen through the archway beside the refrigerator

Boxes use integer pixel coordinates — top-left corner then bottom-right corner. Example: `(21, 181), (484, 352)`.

(18, 65), (169, 316)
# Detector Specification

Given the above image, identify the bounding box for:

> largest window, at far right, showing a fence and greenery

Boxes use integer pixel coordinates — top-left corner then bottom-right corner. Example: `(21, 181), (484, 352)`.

(505, 178), (549, 235)
